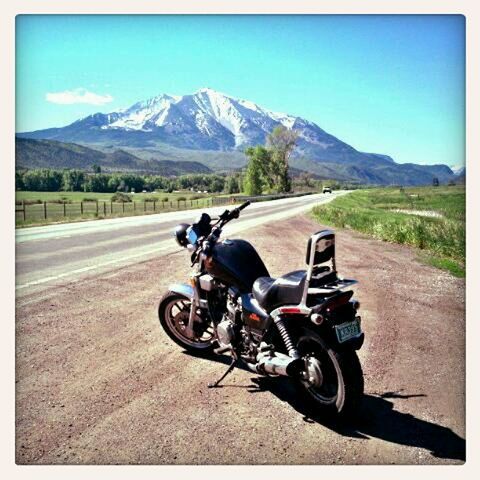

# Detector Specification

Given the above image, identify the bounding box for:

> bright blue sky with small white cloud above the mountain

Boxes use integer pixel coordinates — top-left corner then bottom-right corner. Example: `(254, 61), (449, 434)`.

(16, 15), (465, 165)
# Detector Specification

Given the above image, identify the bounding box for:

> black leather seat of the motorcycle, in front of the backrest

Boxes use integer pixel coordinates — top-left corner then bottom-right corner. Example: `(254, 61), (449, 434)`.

(252, 270), (307, 313)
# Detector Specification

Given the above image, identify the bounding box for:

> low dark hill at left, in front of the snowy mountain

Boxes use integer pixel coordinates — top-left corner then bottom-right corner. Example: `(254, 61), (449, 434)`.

(15, 138), (212, 176)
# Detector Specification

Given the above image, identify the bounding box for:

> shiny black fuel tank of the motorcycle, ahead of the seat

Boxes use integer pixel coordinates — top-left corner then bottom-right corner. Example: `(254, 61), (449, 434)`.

(205, 240), (269, 293)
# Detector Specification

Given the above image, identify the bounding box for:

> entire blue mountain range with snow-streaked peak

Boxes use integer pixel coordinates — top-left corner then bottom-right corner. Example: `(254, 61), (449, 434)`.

(17, 88), (455, 185)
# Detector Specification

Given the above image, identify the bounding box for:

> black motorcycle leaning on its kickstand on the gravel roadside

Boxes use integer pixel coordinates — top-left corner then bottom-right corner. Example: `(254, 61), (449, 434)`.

(158, 202), (364, 416)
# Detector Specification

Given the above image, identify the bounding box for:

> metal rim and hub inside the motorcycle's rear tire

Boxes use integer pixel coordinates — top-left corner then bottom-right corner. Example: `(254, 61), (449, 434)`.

(298, 337), (345, 410)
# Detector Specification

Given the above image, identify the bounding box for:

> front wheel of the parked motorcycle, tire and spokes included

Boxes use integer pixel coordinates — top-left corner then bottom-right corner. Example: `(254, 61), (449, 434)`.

(158, 291), (214, 355)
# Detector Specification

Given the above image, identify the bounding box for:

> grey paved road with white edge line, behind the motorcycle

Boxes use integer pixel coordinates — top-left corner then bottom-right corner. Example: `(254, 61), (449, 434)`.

(16, 192), (345, 296)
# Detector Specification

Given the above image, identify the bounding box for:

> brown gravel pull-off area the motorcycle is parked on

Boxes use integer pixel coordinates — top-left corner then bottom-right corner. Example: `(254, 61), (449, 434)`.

(16, 217), (465, 464)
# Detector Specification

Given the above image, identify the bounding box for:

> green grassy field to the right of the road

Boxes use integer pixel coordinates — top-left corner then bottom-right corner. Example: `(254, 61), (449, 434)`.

(312, 186), (465, 277)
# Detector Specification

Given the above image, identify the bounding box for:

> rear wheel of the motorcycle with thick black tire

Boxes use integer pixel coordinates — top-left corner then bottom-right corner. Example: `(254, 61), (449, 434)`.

(297, 329), (364, 418)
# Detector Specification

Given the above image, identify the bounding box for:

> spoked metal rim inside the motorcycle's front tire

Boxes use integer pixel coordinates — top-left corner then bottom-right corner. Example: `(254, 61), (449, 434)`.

(164, 298), (214, 349)
